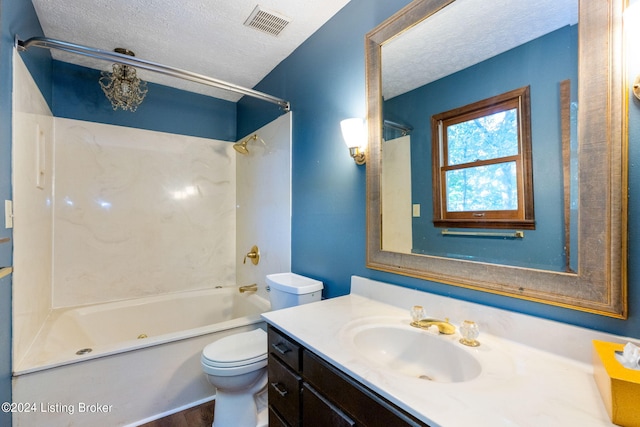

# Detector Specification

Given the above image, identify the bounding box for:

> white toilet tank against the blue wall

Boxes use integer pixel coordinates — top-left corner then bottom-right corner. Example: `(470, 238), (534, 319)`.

(267, 273), (323, 310)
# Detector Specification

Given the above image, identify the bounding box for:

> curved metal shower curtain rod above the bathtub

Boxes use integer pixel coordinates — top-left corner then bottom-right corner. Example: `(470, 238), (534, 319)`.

(16, 37), (291, 112)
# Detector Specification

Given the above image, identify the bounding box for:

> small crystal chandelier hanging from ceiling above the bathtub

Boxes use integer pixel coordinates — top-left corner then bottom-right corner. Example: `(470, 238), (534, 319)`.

(99, 48), (148, 112)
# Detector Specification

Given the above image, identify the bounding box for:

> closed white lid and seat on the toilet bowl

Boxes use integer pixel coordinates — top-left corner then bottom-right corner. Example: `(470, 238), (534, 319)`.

(202, 329), (267, 367)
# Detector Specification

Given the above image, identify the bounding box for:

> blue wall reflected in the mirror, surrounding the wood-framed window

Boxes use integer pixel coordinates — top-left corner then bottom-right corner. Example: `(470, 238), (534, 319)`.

(383, 26), (578, 271)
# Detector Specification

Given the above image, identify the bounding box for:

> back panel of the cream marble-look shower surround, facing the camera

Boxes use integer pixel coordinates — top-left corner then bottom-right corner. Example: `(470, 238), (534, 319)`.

(52, 118), (236, 307)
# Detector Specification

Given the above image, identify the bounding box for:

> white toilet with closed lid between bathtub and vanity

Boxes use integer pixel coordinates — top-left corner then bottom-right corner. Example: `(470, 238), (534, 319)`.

(200, 273), (323, 427)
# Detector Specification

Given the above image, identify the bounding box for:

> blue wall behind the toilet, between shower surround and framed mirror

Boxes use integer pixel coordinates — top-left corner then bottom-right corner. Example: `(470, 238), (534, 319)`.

(238, 0), (412, 297)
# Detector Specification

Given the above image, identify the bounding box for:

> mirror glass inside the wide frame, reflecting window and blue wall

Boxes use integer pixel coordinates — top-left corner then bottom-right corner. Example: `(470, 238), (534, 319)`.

(381, 0), (578, 272)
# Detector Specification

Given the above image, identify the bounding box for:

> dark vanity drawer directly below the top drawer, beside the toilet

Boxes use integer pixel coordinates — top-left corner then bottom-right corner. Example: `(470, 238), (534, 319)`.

(267, 356), (302, 426)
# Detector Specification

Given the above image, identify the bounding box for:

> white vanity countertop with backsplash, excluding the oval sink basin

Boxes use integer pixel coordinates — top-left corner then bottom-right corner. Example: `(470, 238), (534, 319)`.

(263, 278), (620, 427)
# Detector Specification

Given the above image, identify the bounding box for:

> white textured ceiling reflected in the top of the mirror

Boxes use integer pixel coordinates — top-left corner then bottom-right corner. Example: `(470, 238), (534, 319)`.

(382, 0), (578, 99)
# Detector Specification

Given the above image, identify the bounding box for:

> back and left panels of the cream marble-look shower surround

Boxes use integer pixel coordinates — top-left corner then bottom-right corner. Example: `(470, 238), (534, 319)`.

(13, 47), (236, 362)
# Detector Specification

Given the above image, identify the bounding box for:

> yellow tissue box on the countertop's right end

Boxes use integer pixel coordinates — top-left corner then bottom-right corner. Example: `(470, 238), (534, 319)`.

(593, 340), (640, 427)
